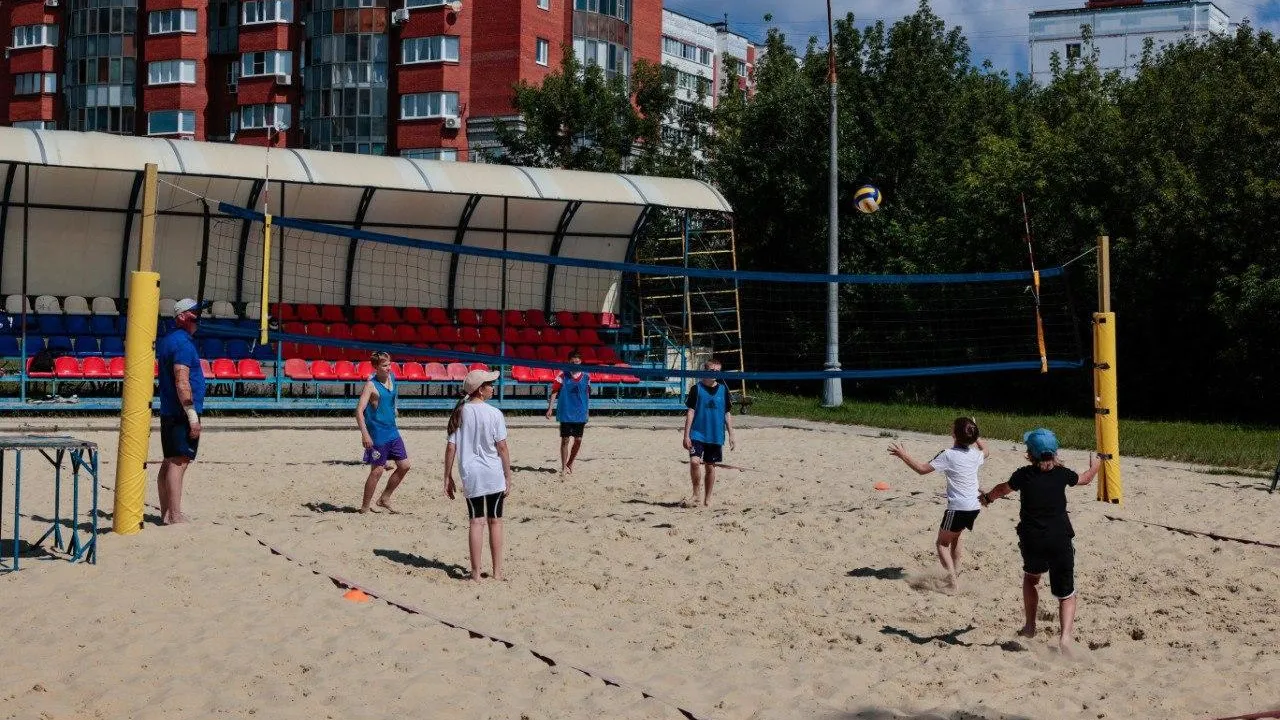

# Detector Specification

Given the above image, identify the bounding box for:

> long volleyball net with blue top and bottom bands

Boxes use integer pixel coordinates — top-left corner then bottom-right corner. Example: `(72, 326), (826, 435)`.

(201, 204), (1084, 380)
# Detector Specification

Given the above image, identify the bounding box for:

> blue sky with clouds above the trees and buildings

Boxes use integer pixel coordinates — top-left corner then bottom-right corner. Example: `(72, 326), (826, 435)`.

(663, 0), (1280, 73)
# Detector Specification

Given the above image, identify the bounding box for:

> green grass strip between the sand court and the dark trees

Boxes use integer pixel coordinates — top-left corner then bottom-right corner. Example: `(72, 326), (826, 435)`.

(749, 392), (1280, 477)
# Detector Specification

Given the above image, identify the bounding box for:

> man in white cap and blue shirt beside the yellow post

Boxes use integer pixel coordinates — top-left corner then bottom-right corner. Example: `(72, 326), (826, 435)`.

(156, 299), (205, 525)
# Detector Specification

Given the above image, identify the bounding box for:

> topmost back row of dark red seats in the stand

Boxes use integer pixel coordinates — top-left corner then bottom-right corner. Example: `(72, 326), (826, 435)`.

(280, 302), (618, 328)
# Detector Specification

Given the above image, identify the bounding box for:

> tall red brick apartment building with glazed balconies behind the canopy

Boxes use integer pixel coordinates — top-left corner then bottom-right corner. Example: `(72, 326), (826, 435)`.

(10, 0), (662, 160)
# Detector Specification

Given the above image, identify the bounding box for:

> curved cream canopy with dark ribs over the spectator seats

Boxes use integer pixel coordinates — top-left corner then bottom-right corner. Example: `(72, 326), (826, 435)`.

(0, 128), (732, 311)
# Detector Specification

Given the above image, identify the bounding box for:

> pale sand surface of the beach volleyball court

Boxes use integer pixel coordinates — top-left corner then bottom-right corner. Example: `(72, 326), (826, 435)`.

(0, 418), (1280, 720)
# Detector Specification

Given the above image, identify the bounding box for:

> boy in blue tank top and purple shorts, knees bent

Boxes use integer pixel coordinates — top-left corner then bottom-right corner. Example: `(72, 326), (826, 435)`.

(356, 352), (413, 512)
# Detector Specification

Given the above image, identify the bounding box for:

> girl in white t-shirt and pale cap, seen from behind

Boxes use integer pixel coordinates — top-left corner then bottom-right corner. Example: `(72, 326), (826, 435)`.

(444, 370), (511, 582)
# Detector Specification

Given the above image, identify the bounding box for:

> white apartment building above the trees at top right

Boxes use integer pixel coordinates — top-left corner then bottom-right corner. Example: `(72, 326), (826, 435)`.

(1028, 0), (1231, 85)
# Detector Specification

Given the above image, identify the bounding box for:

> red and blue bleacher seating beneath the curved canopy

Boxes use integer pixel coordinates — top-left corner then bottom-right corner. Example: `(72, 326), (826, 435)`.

(0, 288), (678, 409)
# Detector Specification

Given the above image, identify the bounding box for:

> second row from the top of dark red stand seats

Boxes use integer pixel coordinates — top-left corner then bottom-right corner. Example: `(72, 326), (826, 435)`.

(280, 322), (604, 345)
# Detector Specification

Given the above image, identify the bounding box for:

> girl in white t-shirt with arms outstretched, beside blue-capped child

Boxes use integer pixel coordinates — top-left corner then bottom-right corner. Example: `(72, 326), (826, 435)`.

(888, 418), (989, 589)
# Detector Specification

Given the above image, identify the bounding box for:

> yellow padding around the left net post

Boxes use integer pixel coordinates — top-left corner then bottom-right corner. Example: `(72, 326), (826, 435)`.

(113, 272), (160, 536)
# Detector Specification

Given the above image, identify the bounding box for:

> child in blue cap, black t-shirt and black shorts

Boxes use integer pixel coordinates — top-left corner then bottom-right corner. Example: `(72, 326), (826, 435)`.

(979, 428), (1100, 653)
